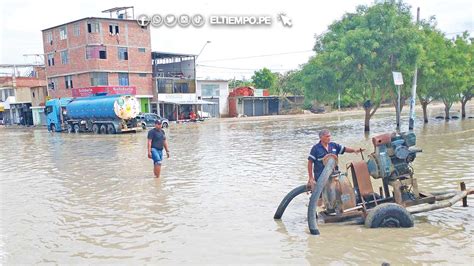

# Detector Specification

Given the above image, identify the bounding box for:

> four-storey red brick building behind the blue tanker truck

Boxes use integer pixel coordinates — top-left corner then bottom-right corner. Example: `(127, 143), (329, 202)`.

(42, 10), (153, 112)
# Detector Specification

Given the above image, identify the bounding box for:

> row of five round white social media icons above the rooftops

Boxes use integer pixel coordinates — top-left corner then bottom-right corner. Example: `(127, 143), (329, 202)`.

(137, 14), (206, 28)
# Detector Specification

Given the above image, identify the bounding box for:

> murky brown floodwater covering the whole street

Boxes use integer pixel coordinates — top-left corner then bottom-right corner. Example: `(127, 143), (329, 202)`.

(0, 105), (474, 265)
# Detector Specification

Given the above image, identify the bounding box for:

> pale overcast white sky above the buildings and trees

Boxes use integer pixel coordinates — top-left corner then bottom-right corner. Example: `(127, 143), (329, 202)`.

(0, 0), (474, 79)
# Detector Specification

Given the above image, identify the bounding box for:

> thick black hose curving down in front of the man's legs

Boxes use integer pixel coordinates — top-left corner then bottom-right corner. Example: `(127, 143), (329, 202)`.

(308, 157), (336, 235)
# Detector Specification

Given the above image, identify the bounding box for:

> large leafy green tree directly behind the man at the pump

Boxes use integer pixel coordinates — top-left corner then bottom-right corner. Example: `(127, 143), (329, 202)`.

(305, 2), (422, 131)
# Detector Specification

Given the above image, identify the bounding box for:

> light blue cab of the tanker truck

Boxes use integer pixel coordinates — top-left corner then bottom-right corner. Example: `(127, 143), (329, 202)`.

(44, 98), (72, 132)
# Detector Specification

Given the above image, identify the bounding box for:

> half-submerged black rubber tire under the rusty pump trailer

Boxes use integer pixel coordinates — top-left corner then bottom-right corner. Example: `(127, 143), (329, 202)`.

(365, 203), (414, 228)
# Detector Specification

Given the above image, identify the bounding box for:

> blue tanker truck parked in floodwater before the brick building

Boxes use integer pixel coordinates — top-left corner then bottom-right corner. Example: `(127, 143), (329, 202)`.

(45, 94), (141, 134)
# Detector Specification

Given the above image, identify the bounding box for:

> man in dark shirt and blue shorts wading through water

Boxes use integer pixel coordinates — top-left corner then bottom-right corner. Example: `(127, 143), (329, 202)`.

(148, 120), (170, 178)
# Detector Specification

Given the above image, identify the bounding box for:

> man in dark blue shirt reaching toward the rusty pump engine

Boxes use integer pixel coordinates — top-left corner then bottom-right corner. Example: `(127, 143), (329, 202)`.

(307, 129), (364, 191)
